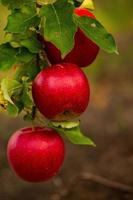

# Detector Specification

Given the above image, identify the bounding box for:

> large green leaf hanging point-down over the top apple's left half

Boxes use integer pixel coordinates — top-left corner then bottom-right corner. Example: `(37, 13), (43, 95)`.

(40, 0), (77, 57)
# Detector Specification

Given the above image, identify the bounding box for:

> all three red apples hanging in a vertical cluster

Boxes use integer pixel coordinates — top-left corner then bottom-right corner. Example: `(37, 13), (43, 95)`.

(7, 8), (99, 182)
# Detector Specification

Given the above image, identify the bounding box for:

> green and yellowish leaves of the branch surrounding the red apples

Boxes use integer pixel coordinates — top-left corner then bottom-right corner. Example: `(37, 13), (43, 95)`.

(0, 0), (117, 145)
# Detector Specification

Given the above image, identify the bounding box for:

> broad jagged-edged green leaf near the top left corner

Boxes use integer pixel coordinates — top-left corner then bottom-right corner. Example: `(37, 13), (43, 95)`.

(5, 6), (40, 33)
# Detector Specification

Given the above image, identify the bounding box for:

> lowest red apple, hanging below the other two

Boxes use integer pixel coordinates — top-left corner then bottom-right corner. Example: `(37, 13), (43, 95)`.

(7, 127), (65, 182)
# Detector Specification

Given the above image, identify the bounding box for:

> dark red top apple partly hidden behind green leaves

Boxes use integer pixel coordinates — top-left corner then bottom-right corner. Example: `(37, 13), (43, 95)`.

(43, 8), (99, 67)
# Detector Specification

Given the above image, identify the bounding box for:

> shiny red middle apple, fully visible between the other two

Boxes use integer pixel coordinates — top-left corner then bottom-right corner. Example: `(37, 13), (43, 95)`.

(32, 63), (90, 121)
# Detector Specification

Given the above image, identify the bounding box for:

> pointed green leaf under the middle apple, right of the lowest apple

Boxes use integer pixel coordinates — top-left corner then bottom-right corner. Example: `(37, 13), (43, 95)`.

(50, 122), (95, 146)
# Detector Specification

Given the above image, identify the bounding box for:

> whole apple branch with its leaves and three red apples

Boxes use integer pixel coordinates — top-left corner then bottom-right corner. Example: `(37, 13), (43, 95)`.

(0, 0), (118, 182)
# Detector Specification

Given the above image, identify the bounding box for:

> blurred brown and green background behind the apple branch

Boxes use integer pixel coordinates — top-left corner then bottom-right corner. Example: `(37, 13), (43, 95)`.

(0, 0), (133, 200)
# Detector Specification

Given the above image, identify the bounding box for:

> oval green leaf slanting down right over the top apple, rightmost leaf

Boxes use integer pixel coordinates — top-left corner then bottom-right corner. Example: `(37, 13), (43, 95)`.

(74, 14), (118, 53)
